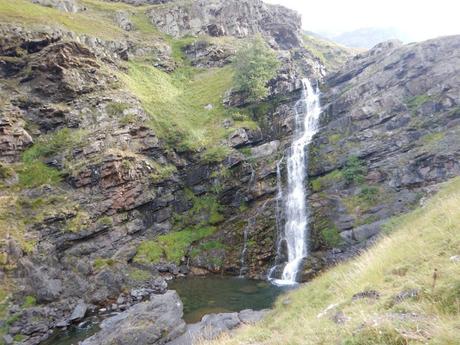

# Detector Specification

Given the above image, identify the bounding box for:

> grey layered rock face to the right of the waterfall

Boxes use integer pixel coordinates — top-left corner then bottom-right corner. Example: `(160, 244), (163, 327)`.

(309, 36), (460, 266)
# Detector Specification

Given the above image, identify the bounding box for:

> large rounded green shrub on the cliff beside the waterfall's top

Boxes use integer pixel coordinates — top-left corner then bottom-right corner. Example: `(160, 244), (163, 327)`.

(234, 35), (280, 101)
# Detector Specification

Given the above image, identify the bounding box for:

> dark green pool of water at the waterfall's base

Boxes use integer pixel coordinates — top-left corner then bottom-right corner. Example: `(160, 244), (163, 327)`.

(168, 276), (284, 323)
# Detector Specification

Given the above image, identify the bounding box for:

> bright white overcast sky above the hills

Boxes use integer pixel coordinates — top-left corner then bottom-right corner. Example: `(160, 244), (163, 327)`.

(264, 0), (460, 41)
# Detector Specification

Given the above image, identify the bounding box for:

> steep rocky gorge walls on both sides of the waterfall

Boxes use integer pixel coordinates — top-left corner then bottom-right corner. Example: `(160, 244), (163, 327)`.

(0, 0), (460, 344)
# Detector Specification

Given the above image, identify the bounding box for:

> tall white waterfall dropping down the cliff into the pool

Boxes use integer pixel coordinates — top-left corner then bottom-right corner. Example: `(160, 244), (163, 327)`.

(269, 79), (321, 285)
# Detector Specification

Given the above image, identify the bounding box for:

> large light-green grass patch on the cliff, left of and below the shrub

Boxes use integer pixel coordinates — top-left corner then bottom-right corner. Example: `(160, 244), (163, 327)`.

(121, 62), (252, 150)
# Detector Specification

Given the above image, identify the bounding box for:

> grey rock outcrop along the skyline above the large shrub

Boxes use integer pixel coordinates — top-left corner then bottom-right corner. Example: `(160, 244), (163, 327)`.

(148, 0), (301, 49)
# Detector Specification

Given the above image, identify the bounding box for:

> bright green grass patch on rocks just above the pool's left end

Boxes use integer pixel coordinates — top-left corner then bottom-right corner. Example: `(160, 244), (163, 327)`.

(134, 226), (216, 264)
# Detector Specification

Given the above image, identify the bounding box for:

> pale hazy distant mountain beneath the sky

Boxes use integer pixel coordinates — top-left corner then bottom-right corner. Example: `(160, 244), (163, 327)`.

(323, 28), (411, 49)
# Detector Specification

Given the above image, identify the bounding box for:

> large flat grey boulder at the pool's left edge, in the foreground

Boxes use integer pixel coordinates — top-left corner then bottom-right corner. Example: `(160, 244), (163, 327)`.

(82, 291), (186, 345)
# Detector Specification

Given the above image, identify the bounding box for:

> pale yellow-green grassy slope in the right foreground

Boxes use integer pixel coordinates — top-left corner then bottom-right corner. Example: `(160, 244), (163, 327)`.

(209, 178), (460, 345)
